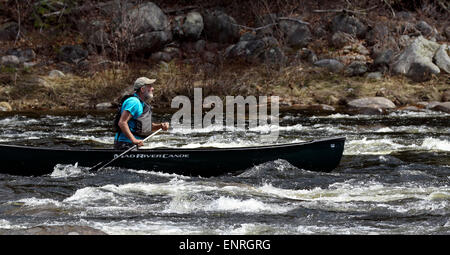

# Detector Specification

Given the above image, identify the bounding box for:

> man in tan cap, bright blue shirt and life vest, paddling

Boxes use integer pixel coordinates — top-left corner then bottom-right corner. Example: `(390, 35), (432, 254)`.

(114, 77), (169, 150)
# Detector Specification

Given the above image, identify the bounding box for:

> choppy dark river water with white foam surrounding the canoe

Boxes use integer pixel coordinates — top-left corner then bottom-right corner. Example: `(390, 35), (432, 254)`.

(0, 111), (450, 235)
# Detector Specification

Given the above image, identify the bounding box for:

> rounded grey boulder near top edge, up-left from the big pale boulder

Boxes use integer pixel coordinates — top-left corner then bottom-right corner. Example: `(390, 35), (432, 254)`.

(331, 13), (367, 38)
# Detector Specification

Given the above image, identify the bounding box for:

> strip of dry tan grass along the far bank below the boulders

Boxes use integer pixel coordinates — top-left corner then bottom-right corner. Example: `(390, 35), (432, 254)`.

(0, 58), (450, 110)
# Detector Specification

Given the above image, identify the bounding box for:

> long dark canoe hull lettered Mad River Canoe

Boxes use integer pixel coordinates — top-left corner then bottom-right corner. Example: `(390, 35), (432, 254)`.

(0, 137), (345, 177)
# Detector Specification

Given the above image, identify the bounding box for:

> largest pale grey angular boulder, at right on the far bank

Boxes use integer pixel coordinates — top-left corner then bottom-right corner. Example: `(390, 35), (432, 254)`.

(391, 36), (440, 81)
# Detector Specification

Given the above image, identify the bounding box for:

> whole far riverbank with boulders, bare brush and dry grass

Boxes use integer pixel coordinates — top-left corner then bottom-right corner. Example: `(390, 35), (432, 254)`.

(0, 0), (450, 114)
